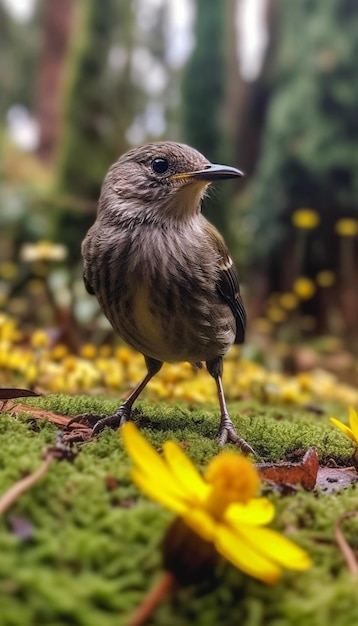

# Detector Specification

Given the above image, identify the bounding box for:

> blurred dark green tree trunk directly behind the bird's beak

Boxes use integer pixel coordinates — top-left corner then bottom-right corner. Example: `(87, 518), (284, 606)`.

(182, 0), (238, 235)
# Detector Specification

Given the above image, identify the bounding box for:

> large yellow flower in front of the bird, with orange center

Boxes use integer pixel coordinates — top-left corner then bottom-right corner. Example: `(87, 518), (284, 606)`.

(121, 422), (310, 583)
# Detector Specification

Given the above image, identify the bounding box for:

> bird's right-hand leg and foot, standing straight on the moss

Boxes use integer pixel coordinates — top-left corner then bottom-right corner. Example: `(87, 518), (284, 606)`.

(206, 357), (257, 456)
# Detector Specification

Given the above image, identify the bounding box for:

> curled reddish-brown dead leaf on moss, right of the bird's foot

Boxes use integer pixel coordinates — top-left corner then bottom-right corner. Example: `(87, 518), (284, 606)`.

(256, 447), (319, 489)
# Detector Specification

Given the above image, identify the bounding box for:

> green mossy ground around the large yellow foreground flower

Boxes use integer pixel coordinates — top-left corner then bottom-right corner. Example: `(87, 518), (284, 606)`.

(0, 396), (358, 626)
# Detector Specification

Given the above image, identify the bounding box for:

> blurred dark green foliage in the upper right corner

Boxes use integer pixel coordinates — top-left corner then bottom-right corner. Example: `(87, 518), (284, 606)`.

(248, 0), (358, 270)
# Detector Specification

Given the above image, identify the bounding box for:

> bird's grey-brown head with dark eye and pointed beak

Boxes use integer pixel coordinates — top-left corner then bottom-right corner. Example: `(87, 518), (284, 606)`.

(99, 141), (243, 223)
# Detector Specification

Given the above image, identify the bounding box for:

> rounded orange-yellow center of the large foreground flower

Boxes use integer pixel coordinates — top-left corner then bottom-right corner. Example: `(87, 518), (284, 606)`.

(204, 452), (260, 520)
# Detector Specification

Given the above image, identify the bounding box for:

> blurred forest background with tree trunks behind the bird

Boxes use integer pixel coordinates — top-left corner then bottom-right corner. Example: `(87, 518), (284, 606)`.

(0, 0), (358, 382)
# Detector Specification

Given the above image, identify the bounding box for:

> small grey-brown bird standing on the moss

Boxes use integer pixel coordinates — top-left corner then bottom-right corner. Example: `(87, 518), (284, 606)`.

(81, 141), (255, 453)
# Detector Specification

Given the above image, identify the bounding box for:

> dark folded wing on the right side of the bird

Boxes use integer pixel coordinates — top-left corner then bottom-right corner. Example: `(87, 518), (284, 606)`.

(205, 222), (246, 343)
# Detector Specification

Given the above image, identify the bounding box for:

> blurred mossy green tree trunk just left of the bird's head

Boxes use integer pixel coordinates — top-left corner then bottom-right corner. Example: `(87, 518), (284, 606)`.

(54, 0), (133, 260)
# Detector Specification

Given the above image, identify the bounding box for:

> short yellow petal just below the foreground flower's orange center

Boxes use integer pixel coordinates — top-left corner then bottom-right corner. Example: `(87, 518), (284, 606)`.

(224, 498), (275, 530)
